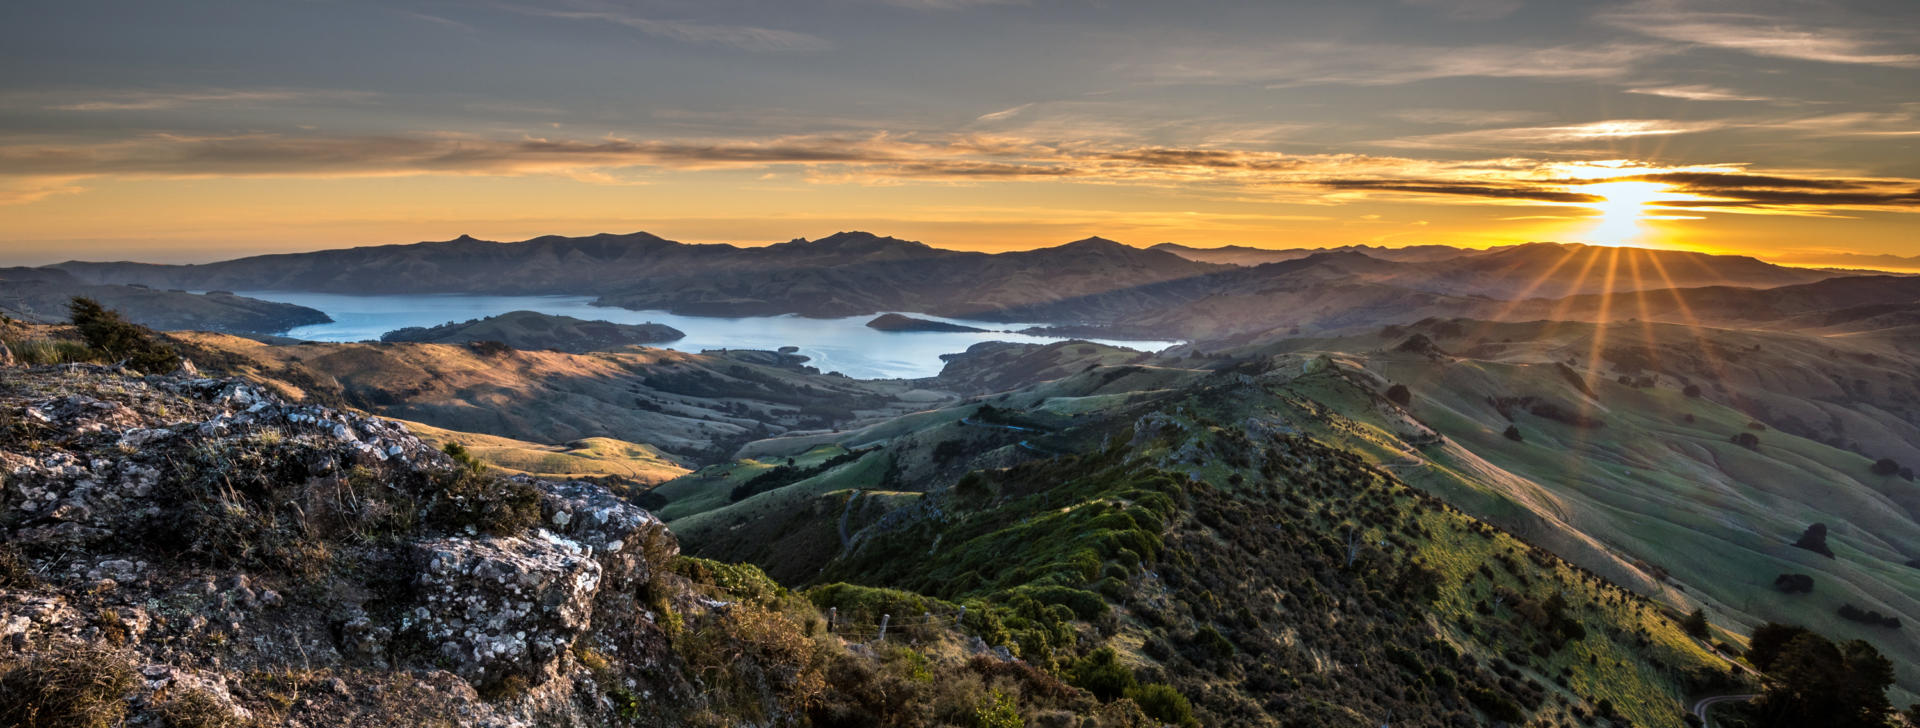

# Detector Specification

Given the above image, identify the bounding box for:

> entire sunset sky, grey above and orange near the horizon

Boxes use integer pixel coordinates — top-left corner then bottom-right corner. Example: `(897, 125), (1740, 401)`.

(0, 0), (1920, 267)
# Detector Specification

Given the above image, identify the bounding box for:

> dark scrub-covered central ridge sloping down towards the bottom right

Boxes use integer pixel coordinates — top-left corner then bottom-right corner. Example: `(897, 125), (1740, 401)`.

(662, 357), (1758, 726)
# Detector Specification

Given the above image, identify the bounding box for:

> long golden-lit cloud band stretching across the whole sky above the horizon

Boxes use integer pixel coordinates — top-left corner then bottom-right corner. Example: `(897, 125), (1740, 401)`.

(0, 123), (1920, 215)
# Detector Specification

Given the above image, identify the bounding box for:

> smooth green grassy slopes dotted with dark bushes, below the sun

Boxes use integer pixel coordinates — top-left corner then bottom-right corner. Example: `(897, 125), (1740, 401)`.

(1244, 325), (1920, 701)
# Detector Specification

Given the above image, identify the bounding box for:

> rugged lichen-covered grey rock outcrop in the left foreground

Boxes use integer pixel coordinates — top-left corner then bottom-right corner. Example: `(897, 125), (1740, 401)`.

(0, 365), (705, 726)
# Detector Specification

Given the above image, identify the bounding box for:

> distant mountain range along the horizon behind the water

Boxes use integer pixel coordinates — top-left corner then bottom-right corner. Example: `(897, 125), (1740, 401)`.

(41, 232), (1873, 340)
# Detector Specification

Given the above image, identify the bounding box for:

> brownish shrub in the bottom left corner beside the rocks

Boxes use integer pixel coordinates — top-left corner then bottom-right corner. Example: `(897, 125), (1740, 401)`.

(0, 647), (134, 728)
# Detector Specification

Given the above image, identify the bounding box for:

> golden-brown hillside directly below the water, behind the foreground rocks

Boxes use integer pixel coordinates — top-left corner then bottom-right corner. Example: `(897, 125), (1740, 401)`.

(177, 334), (956, 461)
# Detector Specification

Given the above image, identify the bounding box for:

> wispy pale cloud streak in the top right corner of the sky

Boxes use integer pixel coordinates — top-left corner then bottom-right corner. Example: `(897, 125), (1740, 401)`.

(1596, 0), (1920, 67)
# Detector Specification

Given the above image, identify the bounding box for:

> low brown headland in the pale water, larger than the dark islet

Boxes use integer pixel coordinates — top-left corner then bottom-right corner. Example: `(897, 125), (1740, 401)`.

(380, 311), (687, 353)
